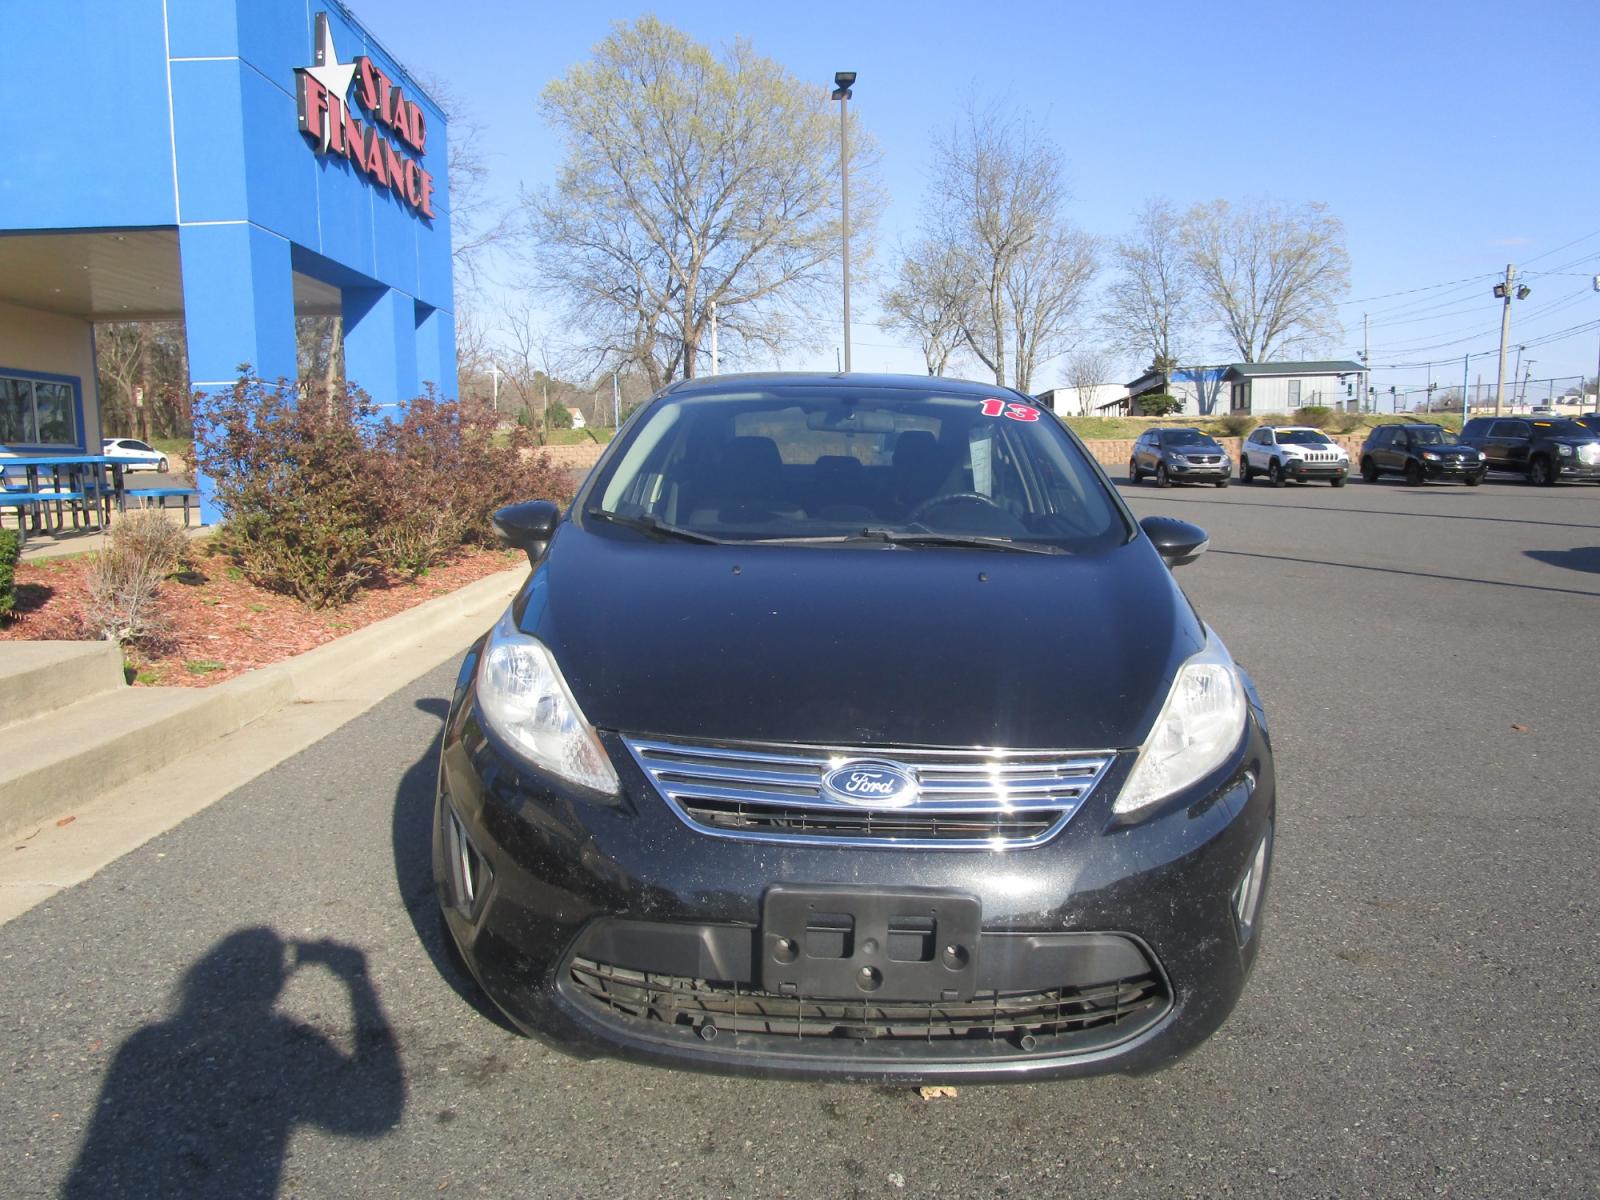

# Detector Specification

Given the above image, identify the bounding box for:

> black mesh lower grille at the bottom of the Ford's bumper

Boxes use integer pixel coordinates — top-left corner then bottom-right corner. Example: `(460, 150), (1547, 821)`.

(570, 958), (1168, 1054)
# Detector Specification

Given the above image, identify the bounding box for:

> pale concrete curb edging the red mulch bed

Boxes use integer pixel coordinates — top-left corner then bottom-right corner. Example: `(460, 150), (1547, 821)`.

(0, 566), (528, 837)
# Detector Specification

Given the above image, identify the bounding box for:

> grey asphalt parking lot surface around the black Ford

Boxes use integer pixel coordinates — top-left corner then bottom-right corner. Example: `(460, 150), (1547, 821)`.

(0, 482), (1600, 1197)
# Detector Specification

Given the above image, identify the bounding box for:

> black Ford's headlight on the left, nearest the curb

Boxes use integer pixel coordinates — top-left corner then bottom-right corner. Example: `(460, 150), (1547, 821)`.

(477, 608), (618, 795)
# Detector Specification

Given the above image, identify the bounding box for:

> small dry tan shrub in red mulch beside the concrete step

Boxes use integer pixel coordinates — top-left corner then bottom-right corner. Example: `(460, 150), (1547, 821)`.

(83, 512), (189, 645)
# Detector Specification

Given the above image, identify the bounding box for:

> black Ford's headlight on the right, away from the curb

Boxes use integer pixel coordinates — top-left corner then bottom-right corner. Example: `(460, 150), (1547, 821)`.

(1112, 630), (1248, 814)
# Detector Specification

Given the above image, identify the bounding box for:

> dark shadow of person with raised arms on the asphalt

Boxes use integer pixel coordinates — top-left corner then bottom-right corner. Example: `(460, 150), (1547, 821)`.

(61, 928), (405, 1200)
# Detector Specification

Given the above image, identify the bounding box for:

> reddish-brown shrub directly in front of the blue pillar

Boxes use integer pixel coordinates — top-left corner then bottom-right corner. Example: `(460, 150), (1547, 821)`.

(195, 374), (381, 608)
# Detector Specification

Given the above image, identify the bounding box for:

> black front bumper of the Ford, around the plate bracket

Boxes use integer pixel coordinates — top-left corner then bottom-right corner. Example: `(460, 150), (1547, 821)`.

(434, 659), (1275, 1083)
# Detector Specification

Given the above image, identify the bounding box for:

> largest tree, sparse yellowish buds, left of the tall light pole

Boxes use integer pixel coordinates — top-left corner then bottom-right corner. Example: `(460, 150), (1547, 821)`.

(525, 16), (882, 386)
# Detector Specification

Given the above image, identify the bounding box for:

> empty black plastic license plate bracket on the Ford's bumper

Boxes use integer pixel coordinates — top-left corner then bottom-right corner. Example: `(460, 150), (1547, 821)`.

(760, 883), (982, 1003)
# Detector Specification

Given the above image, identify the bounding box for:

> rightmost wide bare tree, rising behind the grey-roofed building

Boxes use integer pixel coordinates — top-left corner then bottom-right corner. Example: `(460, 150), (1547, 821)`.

(1182, 200), (1350, 363)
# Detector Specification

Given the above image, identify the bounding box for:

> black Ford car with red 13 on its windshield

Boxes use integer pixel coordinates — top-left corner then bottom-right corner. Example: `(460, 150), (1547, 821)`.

(434, 374), (1275, 1082)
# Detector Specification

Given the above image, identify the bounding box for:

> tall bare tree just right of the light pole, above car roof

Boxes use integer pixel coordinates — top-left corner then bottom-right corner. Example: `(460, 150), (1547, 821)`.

(925, 104), (1094, 390)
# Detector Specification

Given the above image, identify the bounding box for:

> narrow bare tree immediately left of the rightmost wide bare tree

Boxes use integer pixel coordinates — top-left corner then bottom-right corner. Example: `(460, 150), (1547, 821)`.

(1104, 200), (1195, 371)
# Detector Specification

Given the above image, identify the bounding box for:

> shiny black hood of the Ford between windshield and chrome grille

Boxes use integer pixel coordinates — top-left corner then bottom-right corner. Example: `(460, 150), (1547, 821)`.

(517, 522), (1205, 749)
